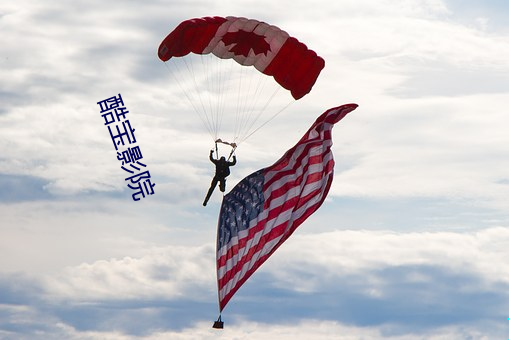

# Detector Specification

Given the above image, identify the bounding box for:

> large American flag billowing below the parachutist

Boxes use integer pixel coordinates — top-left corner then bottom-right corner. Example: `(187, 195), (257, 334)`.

(216, 104), (357, 311)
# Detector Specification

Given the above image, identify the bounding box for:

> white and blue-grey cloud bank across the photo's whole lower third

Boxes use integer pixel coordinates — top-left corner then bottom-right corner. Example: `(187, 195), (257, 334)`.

(2, 228), (500, 339)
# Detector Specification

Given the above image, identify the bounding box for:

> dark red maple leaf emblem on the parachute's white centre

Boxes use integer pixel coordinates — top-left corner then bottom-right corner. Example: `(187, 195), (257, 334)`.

(222, 31), (270, 57)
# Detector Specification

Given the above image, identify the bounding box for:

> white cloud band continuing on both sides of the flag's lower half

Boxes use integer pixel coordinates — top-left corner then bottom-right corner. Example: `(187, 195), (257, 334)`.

(33, 227), (509, 314)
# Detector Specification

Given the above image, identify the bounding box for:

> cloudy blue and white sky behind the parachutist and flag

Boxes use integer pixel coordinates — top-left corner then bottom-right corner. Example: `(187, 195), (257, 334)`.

(0, 0), (509, 339)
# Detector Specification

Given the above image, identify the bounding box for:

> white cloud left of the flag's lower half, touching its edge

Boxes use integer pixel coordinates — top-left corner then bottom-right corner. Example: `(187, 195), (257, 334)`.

(46, 246), (215, 301)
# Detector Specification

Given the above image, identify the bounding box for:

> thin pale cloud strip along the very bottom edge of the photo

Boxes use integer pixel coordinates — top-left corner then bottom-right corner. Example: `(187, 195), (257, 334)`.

(4, 320), (503, 340)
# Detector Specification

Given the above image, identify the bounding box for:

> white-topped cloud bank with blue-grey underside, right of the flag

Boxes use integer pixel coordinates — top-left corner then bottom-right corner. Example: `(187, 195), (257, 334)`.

(229, 228), (509, 334)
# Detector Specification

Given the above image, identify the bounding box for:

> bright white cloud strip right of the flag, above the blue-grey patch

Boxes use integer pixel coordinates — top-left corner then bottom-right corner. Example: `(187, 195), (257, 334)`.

(263, 227), (509, 292)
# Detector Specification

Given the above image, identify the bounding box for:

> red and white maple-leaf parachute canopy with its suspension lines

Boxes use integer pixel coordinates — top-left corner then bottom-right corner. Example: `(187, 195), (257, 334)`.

(158, 16), (325, 147)
